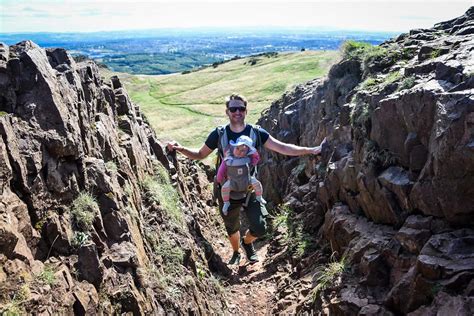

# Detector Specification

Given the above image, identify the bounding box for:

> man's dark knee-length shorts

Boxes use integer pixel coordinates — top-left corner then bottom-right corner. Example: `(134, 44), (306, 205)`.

(219, 193), (268, 237)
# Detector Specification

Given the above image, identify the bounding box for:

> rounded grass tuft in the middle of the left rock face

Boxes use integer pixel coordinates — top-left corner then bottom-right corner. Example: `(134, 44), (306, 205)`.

(71, 192), (99, 231)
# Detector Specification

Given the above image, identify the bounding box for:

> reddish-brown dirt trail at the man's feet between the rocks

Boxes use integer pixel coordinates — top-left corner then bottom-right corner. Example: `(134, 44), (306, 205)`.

(218, 241), (276, 315)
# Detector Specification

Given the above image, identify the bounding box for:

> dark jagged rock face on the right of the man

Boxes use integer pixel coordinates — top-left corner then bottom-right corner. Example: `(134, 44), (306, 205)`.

(258, 7), (474, 315)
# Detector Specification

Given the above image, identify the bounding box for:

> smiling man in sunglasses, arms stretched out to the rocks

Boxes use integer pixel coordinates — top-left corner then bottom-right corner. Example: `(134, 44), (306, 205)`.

(167, 94), (328, 264)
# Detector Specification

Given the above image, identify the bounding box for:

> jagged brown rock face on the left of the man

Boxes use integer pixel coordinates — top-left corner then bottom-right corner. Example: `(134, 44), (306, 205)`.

(0, 41), (223, 314)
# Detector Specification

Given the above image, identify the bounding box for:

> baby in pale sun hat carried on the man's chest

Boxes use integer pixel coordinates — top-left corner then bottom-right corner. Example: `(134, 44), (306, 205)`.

(217, 135), (266, 215)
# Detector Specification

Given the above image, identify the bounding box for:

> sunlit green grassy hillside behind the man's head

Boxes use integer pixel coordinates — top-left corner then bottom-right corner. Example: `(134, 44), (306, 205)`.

(104, 51), (338, 147)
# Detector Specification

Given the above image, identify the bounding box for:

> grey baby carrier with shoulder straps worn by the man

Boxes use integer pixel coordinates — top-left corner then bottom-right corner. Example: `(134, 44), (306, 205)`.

(214, 125), (262, 200)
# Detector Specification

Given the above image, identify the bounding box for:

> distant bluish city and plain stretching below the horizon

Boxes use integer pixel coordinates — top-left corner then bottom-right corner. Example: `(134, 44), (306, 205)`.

(0, 29), (398, 75)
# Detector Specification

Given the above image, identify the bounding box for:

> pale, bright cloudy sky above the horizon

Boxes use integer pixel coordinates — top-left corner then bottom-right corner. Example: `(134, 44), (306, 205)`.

(0, 0), (474, 33)
